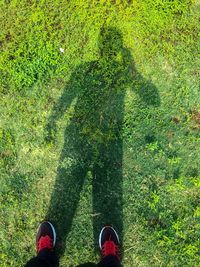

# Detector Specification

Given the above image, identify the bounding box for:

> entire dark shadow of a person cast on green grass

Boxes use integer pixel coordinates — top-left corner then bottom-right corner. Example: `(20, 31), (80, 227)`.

(46, 27), (160, 256)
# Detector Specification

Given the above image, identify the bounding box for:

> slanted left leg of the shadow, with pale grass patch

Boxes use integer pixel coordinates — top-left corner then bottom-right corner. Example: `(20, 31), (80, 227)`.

(46, 120), (89, 257)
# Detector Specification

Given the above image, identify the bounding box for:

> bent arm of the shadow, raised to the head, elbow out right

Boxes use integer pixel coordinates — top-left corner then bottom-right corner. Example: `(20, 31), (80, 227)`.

(122, 48), (160, 107)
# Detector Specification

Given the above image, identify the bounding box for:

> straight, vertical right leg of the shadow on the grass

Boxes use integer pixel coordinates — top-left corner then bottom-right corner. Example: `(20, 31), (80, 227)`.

(93, 139), (123, 247)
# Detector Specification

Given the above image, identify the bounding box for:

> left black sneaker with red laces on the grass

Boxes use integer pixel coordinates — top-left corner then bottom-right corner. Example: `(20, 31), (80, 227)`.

(36, 221), (56, 254)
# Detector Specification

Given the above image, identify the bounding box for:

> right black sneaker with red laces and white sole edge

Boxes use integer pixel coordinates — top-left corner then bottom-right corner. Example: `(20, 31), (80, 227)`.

(99, 225), (120, 259)
